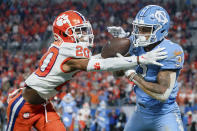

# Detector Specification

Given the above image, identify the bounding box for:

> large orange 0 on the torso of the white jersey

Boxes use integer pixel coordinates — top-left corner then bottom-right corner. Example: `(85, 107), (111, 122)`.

(35, 47), (59, 77)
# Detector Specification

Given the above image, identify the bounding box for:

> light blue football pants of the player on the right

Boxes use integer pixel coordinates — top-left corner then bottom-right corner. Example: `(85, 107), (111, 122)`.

(124, 110), (184, 131)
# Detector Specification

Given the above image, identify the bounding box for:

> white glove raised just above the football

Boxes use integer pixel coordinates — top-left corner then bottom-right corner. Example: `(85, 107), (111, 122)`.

(107, 26), (130, 38)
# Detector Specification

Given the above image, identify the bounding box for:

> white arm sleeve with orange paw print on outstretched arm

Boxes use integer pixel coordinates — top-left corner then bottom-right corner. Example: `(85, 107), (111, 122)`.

(87, 56), (137, 71)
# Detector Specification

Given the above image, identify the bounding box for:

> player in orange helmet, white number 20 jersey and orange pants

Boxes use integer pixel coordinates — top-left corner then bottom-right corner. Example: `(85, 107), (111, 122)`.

(7, 10), (166, 131)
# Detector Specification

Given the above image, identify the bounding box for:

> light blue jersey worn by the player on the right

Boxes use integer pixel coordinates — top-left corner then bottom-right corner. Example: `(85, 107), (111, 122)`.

(130, 36), (184, 113)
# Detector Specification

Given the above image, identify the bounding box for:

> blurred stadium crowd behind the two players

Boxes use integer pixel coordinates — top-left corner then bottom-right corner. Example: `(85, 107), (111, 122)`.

(0, 0), (197, 131)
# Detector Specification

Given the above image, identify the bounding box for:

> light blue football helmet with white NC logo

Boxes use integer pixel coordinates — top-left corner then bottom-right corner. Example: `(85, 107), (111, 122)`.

(132, 5), (170, 47)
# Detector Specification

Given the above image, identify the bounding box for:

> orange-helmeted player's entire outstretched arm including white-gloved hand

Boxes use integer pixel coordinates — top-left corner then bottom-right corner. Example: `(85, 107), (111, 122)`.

(63, 48), (167, 72)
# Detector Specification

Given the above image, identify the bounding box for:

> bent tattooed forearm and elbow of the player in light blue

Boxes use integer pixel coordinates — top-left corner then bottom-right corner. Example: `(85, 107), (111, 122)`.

(125, 70), (176, 101)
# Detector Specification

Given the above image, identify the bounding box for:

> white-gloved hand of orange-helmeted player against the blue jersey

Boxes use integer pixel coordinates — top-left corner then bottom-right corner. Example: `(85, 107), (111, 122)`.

(139, 48), (167, 66)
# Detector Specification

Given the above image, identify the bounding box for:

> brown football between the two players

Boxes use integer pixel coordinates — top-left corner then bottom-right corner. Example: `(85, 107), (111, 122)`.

(101, 38), (130, 58)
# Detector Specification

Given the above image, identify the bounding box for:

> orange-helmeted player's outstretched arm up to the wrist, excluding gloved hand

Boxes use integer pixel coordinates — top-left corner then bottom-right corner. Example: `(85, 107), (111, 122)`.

(63, 56), (138, 72)
